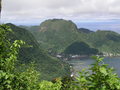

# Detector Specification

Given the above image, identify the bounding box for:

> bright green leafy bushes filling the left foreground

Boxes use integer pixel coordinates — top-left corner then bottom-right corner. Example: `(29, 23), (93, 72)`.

(0, 25), (60, 90)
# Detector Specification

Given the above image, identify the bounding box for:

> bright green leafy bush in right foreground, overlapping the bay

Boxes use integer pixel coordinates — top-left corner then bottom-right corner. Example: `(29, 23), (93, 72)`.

(72, 56), (120, 90)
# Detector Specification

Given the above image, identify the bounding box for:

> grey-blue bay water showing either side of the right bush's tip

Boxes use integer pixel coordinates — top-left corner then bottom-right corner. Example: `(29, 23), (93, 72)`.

(69, 57), (120, 76)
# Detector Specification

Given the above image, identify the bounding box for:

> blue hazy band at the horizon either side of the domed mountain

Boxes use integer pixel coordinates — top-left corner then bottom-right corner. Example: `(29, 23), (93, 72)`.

(6, 19), (120, 33)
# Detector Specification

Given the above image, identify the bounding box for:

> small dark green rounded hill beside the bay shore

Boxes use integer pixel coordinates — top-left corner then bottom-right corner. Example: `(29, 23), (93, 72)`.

(64, 42), (99, 55)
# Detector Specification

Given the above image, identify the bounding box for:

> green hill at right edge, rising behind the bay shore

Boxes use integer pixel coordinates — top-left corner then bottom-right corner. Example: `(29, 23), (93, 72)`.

(85, 30), (120, 55)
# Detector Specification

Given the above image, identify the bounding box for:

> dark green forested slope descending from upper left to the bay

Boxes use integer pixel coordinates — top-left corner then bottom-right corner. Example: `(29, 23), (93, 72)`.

(7, 23), (69, 80)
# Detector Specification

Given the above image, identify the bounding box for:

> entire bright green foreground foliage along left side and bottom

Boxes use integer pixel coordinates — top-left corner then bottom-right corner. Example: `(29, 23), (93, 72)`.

(0, 25), (120, 90)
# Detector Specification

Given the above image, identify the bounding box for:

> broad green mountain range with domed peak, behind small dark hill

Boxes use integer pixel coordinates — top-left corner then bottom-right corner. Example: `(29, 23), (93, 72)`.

(24, 19), (120, 55)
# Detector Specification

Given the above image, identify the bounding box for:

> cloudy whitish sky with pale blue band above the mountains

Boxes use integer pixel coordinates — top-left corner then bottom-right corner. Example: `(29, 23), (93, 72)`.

(2, 0), (120, 32)
